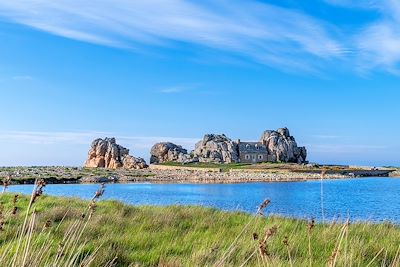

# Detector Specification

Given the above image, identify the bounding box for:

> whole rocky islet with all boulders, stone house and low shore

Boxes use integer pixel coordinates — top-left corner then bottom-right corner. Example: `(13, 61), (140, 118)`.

(0, 128), (394, 183)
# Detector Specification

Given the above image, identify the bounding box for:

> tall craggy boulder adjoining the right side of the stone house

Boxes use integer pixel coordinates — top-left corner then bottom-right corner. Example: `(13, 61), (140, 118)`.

(260, 128), (307, 163)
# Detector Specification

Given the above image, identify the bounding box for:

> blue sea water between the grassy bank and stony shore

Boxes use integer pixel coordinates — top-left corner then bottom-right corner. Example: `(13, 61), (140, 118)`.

(9, 178), (400, 223)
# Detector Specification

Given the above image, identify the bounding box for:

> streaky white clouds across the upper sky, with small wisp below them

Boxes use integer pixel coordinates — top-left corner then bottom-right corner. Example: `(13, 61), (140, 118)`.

(0, 0), (400, 75)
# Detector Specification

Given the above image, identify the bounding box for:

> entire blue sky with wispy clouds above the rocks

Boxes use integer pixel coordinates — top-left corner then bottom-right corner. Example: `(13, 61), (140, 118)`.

(0, 0), (400, 166)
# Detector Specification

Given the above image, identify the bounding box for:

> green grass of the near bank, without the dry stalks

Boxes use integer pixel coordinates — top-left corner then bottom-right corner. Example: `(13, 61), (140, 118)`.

(0, 194), (400, 266)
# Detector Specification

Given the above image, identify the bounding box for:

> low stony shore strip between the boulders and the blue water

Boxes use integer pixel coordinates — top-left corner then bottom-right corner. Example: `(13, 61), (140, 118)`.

(0, 162), (400, 184)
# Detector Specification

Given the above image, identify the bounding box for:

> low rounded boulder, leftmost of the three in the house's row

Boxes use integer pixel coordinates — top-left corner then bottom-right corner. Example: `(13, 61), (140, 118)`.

(150, 142), (195, 164)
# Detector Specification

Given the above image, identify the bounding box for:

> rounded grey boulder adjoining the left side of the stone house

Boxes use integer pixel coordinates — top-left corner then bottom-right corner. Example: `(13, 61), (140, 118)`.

(193, 134), (239, 163)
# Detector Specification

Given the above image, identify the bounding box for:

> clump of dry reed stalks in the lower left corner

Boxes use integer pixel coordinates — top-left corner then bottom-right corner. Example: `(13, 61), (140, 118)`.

(0, 180), (105, 267)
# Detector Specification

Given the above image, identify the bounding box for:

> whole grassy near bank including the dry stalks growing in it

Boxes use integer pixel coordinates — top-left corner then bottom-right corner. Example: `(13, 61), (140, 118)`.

(0, 189), (400, 266)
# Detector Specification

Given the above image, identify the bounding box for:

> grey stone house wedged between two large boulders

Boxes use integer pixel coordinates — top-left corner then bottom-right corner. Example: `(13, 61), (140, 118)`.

(237, 140), (272, 163)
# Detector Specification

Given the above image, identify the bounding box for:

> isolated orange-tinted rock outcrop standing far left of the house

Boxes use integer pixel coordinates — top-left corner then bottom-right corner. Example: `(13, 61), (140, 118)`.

(84, 138), (147, 169)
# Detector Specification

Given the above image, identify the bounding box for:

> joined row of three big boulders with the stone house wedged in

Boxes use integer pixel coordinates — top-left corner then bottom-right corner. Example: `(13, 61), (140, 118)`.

(150, 128), (307, 164)
